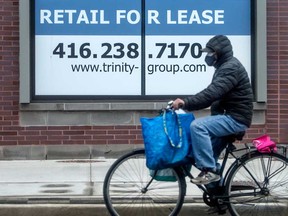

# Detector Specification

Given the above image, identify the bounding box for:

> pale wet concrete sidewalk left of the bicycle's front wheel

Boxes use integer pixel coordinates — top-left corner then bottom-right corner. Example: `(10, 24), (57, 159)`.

(0, 159), (117, 200)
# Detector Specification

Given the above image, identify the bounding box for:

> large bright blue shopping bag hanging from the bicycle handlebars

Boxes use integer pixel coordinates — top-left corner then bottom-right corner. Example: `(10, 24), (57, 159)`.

(140, 110), (195, 170)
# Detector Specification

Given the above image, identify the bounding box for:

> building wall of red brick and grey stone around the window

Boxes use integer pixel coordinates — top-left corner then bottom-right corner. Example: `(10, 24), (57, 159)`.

(0, 0), (288, 159)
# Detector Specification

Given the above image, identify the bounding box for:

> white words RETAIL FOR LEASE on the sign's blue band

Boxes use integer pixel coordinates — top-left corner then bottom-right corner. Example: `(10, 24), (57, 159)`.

(40, 9), (225, 25)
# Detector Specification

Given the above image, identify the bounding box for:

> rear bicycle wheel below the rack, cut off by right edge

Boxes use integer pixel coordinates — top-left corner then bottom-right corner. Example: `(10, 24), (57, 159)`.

(226, 151), (288, 216)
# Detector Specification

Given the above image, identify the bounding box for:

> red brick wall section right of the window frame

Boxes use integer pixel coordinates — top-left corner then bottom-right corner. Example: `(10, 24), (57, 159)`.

(266, 0), (288, 143)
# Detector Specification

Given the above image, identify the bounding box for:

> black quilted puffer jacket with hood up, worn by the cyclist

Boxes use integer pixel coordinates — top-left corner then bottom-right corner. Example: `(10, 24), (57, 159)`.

(184, 35), (253, 127)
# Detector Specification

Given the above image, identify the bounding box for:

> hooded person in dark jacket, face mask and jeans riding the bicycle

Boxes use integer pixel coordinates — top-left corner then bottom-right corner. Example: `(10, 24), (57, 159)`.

(172, 35), (253, 185)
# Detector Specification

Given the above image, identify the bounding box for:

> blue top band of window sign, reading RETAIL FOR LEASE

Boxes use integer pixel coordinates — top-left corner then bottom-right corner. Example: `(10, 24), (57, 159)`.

(35, 0), (251, 35)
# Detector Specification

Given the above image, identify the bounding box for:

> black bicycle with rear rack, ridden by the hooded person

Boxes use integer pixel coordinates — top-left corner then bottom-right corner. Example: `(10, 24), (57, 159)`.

(103, 109), (288, 216)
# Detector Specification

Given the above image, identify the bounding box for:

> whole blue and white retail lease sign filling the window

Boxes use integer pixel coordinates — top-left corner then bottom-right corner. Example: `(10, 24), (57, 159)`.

(34, 0), (252, 99)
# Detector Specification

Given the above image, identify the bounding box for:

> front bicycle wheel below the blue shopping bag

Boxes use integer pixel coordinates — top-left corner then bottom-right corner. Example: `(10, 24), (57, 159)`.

(103, 149), (186, 216)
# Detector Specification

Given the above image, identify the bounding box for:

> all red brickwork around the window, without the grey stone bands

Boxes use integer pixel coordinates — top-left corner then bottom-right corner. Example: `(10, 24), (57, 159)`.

(0, 0), (288, 145)
